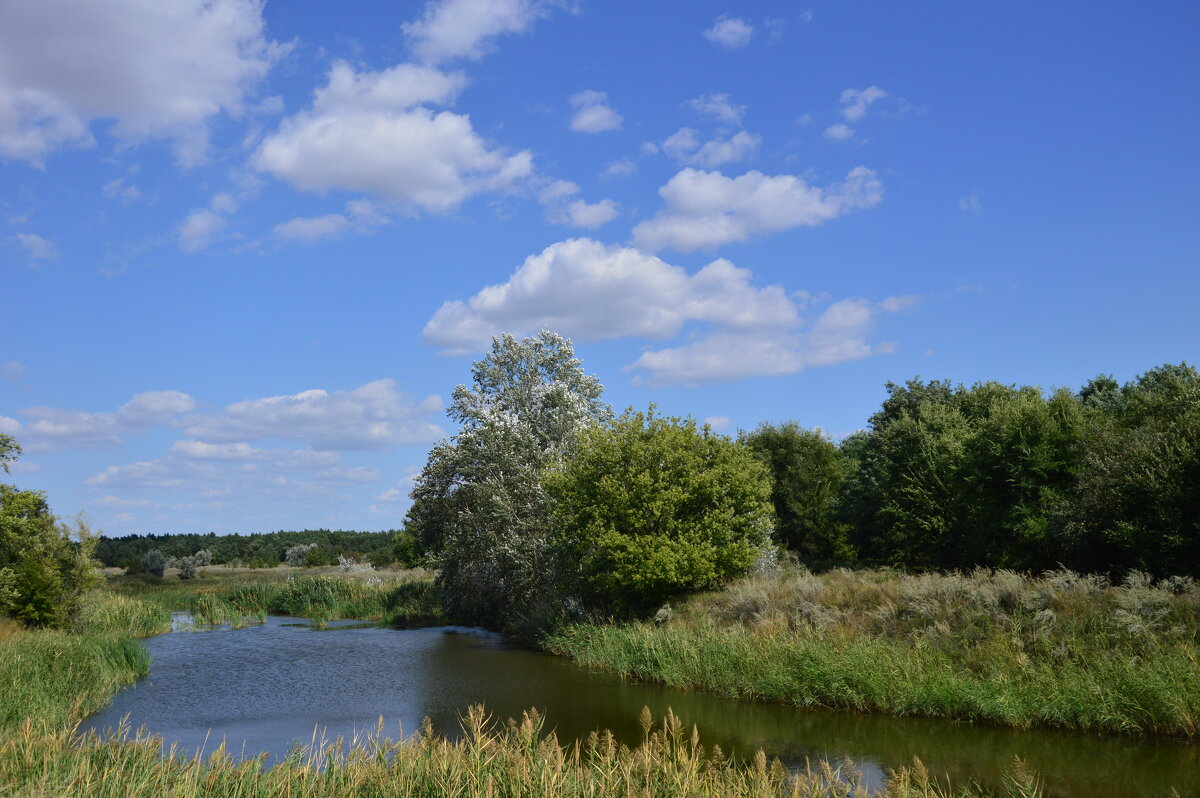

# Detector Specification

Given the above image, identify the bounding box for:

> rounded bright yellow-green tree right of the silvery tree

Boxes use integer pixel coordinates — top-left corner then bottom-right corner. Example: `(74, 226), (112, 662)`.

(546, 407), (770, 612)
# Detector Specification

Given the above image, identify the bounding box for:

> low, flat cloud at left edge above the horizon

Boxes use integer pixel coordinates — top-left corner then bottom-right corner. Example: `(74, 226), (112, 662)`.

(0, 391), (196, 452)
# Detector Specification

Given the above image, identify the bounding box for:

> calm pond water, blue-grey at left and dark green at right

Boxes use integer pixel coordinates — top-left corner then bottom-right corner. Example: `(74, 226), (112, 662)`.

(85, 618), (1200, 798)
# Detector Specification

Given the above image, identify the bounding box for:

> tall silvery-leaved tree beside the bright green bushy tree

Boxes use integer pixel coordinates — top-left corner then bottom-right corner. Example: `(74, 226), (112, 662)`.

(407, 330), (612, 630)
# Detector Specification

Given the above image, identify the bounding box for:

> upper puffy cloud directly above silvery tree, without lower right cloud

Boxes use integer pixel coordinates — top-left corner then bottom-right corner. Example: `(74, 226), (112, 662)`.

(424, 238), (798, 354)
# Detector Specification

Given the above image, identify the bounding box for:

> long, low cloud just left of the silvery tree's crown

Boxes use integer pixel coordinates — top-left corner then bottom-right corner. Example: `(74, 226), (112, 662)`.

(185, 379), (442, 451)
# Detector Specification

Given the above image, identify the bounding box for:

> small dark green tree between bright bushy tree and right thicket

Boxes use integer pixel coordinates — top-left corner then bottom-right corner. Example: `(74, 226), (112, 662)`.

(738, 421), (854, 562)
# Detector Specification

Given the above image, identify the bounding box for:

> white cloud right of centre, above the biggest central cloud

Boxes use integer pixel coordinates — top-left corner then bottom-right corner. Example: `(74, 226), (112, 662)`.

(634, 167), (883, 252)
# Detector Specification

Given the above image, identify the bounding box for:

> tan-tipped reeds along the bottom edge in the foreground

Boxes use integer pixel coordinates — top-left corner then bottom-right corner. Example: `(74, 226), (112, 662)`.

(0, 707), (1042, 798)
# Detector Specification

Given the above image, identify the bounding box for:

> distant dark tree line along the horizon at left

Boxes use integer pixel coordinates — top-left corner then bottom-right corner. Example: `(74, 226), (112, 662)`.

(96, 529), (419, 570)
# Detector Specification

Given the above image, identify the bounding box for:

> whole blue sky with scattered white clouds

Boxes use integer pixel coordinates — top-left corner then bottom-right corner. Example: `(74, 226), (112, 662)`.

(0, 0), (1200, 534)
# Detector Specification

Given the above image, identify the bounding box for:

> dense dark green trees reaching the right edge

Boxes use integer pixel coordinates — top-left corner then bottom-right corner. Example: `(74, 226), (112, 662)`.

(829, 364), (1200, 576)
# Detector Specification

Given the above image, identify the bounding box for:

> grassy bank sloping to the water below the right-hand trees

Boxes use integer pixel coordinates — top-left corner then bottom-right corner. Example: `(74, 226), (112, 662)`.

(545, 568), (1200, 739)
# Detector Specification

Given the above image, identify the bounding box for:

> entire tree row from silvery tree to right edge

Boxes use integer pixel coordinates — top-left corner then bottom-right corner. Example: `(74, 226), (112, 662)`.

(406, 330), (1200, 632)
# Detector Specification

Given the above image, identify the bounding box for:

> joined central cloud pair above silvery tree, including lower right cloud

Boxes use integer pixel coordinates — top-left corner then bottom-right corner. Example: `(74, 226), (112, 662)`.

(422, 239), (918, 384)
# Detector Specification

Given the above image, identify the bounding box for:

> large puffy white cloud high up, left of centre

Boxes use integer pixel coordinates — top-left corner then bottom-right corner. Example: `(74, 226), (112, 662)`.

(252, 62), (533, 212)
